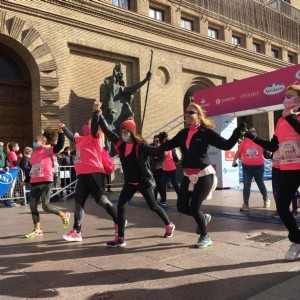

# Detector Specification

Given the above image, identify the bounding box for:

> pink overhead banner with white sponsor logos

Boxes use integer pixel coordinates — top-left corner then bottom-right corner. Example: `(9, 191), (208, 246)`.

(193, 65), (300, 116)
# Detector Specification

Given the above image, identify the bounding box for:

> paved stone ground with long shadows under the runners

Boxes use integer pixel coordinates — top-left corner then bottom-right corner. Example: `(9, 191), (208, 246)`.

(0, 183), (300, 300)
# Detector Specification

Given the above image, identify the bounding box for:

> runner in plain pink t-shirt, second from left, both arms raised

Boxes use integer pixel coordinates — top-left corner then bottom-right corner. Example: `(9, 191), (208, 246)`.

(63, 107), (118, 242)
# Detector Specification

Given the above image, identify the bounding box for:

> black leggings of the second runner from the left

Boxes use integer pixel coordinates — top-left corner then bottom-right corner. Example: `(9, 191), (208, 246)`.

(73, 173), (118, 232)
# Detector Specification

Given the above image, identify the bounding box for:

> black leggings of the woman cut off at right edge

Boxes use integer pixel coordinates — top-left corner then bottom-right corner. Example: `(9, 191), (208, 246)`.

(276, 170), (300, 244)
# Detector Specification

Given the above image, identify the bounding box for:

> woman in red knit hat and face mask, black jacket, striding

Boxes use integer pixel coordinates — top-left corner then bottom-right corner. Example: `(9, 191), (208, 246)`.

(96, 102), (175, 247)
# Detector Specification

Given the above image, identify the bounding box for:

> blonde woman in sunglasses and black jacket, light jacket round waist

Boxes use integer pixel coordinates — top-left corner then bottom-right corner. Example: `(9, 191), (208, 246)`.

(161, 103), (246, 248)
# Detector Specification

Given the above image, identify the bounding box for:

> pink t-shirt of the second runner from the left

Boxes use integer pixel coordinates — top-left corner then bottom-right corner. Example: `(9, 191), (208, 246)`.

(74, 134), (105, 175)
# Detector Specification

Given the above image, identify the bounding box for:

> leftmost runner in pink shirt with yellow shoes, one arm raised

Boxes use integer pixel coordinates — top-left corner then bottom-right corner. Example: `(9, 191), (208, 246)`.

(25, 123), (70, 238)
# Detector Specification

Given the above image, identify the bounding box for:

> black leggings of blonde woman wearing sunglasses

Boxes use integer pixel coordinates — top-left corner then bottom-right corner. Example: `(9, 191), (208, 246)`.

(177, 175), (213, 236)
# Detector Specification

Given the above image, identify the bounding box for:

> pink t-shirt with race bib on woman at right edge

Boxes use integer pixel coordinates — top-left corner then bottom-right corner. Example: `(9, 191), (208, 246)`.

(275, 115), (300, 170)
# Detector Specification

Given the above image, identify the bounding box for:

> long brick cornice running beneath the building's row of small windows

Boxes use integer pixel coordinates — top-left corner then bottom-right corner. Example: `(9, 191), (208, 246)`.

(1, 0), (290, 74)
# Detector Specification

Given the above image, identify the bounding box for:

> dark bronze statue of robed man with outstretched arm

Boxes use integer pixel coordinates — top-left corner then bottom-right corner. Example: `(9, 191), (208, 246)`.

(100, 63), (152, 134)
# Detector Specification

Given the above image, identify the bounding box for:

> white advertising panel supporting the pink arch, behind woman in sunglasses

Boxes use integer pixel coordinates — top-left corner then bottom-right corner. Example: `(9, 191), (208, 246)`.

(208, 115), (239, 188)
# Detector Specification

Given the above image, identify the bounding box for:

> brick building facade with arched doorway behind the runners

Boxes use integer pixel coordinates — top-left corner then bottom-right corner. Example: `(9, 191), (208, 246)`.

(0, 0), (299, 147)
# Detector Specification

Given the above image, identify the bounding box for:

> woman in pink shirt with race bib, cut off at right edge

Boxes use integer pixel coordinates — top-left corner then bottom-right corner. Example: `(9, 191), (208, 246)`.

(245, 84), (300, 260)
